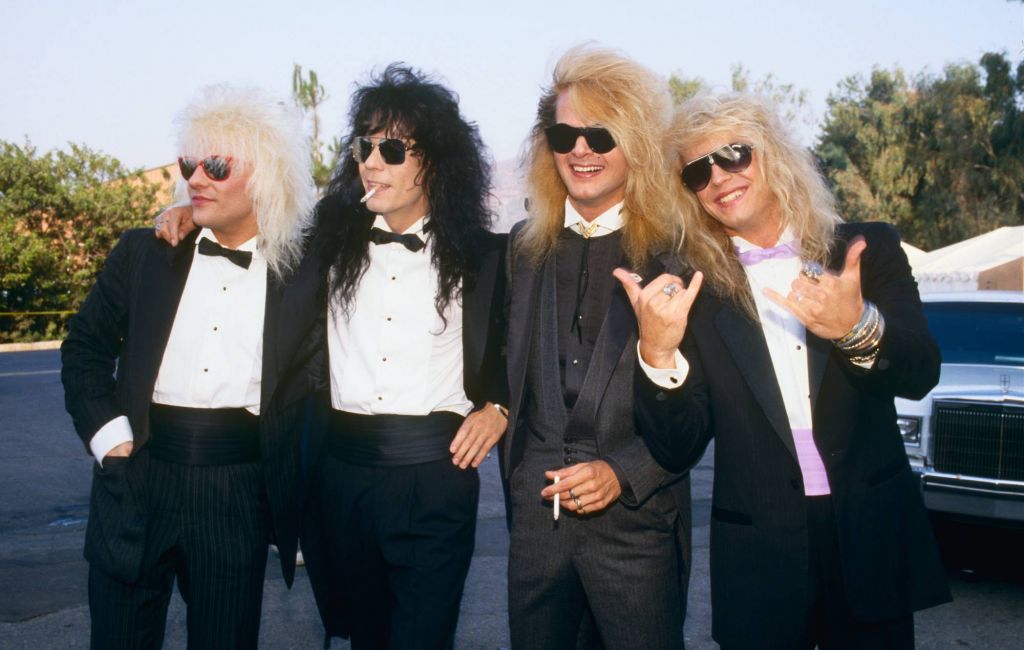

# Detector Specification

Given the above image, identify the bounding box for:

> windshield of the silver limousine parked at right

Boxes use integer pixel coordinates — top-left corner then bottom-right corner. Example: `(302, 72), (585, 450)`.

(925, 302), (1024, 365)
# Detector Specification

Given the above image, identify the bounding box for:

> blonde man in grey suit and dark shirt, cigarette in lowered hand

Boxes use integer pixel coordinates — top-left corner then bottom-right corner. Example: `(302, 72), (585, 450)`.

(502, 47), (699, 649)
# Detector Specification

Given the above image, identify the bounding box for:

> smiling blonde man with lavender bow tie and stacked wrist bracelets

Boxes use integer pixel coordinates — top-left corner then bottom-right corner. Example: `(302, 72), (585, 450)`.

(638, 95), (949, 648)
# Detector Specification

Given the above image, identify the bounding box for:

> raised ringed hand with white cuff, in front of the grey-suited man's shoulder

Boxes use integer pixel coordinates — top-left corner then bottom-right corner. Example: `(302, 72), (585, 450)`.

(614, 268), (700, 367)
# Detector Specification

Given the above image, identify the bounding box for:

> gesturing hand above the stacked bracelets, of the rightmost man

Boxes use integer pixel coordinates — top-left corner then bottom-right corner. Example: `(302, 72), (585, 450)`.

(764, 236), (867, 339)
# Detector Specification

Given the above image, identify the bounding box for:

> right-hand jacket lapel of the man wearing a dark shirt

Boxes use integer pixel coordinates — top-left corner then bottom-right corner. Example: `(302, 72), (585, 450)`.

(565, 280), (637, 437)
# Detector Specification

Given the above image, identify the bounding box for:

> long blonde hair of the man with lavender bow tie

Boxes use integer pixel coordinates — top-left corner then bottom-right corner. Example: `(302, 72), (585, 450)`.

(671, 93), (842, 318)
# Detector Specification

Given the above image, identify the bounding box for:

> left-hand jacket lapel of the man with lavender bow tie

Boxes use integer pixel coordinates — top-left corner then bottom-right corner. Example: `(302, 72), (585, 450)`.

(713, 302), (797, 460)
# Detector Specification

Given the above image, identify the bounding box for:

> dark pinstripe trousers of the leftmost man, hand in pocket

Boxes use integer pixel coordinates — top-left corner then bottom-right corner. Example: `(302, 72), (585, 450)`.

(89, 449), (270, 650)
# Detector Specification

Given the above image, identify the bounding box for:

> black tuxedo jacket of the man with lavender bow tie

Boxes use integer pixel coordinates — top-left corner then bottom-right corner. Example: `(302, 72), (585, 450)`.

(644, 223), (950, 648)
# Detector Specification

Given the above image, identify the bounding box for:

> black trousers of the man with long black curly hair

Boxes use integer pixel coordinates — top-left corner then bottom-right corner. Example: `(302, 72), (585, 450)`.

(318, 456), (480, 650)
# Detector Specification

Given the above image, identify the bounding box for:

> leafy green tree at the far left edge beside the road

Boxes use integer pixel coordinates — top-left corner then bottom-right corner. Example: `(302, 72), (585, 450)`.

(0, 140), (159, 342)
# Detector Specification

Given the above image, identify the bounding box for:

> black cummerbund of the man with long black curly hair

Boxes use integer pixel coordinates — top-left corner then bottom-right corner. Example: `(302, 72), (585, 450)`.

(328, 409), (465, 467)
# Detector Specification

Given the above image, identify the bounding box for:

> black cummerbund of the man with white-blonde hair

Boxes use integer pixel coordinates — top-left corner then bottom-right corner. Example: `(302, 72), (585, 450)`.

(147, 404), (260, 465)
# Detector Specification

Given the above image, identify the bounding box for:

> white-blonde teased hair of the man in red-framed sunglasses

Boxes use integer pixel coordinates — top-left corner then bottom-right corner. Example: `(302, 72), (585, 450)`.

(177, 85), (316, 277)
